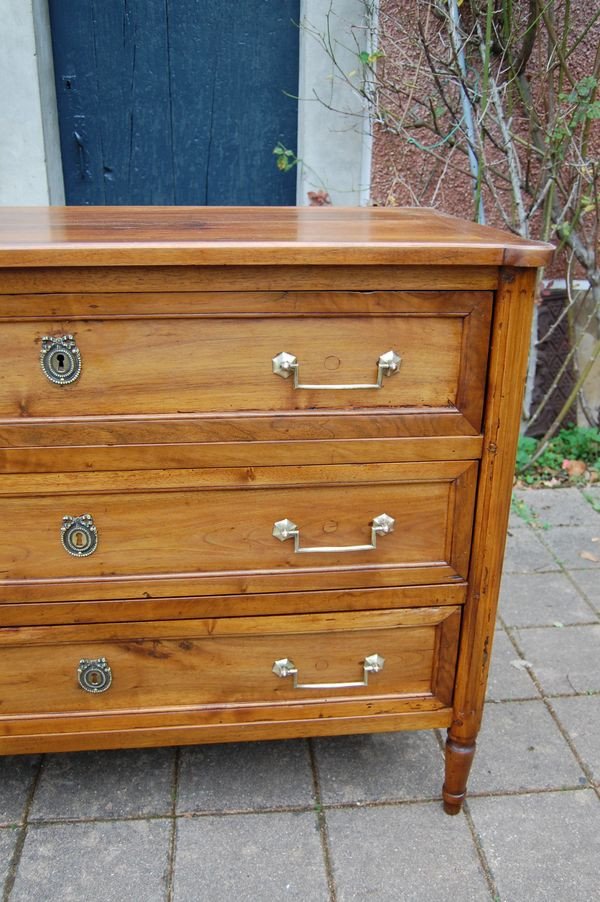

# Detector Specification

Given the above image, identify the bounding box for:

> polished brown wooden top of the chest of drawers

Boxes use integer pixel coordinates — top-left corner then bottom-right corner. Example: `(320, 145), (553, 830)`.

(0, 207), (553, 267)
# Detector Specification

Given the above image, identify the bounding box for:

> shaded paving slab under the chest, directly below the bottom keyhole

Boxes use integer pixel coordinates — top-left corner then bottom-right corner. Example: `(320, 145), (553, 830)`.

(30, 749), (175, 820)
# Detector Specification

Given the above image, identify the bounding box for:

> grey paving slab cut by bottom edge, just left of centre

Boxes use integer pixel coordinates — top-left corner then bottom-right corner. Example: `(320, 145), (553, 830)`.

(173, 812), (330, 902)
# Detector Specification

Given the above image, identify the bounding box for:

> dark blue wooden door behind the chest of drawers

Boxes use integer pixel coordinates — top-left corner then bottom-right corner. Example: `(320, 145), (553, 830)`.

(50, 0), (300, 205)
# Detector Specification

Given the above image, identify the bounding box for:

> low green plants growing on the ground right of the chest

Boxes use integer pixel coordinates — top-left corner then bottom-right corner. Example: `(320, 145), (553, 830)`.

(517, 426), (600, 485)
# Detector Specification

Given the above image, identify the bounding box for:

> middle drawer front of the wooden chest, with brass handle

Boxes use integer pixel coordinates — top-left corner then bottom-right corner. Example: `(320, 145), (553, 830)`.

(0, 461), (477, 600)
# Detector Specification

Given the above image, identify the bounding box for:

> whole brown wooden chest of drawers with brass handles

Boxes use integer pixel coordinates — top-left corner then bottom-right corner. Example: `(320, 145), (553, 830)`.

(0, 208), (550, 813)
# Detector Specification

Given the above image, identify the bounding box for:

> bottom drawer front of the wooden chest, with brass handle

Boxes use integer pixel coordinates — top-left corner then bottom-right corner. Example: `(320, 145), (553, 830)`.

(0, 607), (460, 730)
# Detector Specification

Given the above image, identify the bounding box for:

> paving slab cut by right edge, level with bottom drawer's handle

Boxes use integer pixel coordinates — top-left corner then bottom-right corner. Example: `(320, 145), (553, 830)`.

(514, 625), (600, 695)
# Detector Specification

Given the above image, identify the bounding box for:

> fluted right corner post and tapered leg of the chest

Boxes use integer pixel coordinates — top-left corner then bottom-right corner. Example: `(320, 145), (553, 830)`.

(446, 268), (535, 756)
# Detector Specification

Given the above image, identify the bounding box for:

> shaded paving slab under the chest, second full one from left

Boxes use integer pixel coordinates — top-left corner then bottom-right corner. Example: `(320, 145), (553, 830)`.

(177, 739), (314, 813)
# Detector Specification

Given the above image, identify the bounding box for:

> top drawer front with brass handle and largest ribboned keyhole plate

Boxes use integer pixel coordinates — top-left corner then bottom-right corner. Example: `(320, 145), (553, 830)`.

(0, 292), (491, 432)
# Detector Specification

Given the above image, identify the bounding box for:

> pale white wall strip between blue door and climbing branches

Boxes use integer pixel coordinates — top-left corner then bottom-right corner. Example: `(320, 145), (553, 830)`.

(297, 0), (373, 206)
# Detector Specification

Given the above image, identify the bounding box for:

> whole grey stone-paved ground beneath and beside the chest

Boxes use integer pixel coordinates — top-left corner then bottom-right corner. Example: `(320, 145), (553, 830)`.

(0, 487), (600, 902)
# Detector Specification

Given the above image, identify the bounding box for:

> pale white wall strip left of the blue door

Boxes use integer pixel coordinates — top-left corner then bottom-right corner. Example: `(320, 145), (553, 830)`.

(0, 0), (64, 205)
